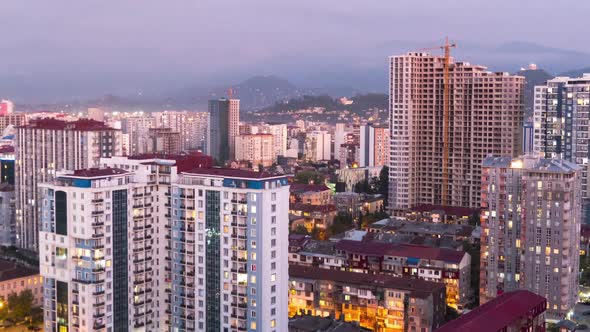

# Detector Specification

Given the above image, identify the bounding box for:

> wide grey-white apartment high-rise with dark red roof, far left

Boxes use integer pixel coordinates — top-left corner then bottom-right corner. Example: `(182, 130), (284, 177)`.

(15, 119), (120, 250)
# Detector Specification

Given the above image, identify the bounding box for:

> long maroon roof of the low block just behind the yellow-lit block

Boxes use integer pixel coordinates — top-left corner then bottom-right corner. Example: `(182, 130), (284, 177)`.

(336, 240), (465, 264)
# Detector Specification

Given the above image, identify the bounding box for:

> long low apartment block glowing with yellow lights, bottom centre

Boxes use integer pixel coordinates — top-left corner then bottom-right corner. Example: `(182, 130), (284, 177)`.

(289, 265), (446, 332)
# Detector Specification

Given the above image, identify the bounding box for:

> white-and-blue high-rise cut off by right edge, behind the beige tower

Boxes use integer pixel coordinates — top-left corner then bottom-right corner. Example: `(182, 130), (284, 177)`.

(534, 74), (590, 199)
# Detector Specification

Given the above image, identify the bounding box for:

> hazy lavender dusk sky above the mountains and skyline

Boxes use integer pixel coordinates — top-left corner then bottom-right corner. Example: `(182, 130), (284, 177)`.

(0, 0), (590, 99)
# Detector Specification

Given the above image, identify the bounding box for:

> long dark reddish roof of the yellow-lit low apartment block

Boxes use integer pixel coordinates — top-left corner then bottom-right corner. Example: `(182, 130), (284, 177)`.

(289, 264), (445, 298)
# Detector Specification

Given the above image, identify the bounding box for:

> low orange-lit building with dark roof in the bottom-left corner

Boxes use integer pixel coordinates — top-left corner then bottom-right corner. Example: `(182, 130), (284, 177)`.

(0, 260), (43, 306)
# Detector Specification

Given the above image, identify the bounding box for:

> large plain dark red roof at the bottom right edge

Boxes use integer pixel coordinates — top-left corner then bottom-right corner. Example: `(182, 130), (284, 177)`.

(436, 290), (547, 332)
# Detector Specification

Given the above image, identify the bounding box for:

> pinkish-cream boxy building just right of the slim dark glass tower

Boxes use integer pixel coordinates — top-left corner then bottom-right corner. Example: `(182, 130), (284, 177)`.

(235, 134), (277, 168)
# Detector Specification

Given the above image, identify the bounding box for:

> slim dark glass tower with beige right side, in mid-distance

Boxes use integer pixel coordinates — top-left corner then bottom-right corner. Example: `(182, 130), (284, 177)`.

(207, 98), (240, 163)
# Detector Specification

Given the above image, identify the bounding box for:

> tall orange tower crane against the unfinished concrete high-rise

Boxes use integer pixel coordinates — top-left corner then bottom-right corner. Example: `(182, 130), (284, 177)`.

(420, 37), (457, 206)
